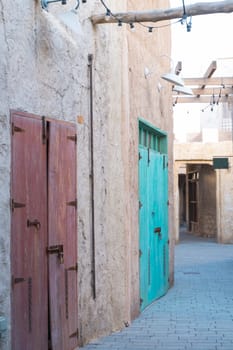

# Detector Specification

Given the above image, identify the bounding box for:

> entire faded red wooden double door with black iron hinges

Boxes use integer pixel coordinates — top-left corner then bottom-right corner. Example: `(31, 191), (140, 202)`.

(11, 112), (78, 350)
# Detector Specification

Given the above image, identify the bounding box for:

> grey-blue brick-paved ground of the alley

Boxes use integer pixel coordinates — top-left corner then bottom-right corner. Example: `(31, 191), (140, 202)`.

(82, 235), (233, 350)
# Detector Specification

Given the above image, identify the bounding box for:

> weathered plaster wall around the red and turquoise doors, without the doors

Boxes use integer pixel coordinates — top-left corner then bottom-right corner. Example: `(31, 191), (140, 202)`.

(0, 0), (173, 350)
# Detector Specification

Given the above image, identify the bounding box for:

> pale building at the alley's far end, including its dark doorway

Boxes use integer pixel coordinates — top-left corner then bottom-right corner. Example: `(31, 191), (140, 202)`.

(174, 100), (233, 244)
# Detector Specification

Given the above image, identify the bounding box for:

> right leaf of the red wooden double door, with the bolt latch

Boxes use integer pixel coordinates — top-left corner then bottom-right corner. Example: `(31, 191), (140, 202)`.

(48, 123), (78, 350)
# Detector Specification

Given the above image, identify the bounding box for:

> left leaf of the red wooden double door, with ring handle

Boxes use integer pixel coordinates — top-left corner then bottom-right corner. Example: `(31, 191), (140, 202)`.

(11, 113), (48, 350)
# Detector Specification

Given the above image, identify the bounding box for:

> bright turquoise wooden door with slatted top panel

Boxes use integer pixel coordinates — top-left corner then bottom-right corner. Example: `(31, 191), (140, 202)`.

(139, 121), (169, 309)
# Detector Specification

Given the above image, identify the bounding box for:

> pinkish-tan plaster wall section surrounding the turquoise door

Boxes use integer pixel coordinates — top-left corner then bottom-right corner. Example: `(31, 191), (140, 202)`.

(128, 0), (175, 290)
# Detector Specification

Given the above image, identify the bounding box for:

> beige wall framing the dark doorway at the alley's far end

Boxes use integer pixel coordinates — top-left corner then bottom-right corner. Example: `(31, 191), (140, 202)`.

(174, 141), (233, 243)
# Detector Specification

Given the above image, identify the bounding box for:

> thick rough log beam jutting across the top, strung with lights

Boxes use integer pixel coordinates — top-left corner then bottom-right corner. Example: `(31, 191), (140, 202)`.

(91, 0), (233, 24)
